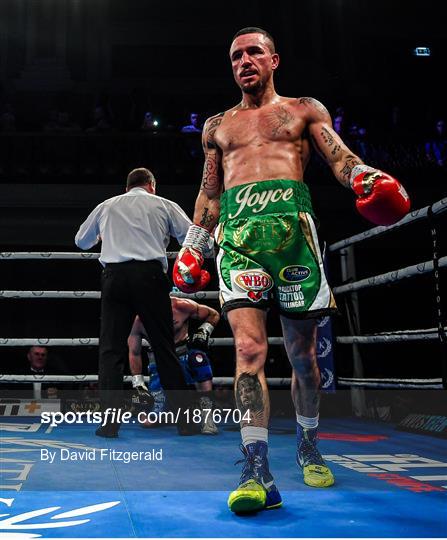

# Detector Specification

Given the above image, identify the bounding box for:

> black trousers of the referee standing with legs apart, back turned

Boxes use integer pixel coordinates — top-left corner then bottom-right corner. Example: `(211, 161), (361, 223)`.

(99, 261), (187, 418)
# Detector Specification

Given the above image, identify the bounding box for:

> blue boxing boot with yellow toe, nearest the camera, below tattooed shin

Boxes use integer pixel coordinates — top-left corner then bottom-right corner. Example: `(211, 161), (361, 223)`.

(228, 441), (282, 513)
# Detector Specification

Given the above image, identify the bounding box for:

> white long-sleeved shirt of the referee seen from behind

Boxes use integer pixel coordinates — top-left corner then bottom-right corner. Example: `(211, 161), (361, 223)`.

(75, 187), (192, 272)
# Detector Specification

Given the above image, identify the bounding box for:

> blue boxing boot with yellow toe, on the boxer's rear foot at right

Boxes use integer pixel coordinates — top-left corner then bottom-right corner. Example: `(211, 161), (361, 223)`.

(296, 424), (335, 487)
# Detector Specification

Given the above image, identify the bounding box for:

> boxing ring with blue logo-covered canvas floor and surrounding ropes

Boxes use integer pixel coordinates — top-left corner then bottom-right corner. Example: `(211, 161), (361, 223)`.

(0, 199), (447, 540)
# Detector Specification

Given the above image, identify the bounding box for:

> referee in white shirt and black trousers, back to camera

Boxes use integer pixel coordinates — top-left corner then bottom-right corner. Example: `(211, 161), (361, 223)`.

(75, 168), (199, 437)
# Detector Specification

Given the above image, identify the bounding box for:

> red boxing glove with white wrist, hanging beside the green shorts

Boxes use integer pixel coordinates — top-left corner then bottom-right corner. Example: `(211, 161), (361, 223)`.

(172, 225), (210, 293)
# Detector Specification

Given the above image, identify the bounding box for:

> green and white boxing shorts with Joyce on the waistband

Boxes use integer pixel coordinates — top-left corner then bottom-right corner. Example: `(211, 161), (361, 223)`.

(215, 180), (337, 319)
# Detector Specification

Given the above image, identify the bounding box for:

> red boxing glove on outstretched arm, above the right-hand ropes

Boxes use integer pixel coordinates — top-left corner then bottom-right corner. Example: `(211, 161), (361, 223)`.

(350, 165), (410, 225)
